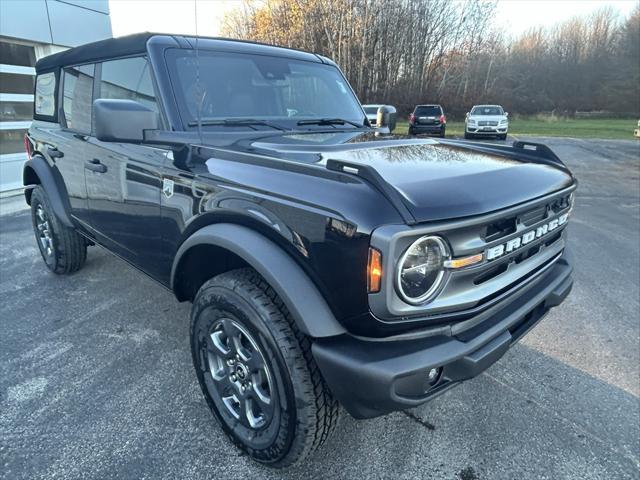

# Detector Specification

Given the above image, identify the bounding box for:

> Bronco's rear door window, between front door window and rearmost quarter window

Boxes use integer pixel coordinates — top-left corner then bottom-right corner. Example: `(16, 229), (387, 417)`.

(62, 65), (94, 133)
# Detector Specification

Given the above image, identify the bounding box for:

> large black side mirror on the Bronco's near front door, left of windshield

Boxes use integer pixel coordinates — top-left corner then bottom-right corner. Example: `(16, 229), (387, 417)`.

(93, 98), (159, 143)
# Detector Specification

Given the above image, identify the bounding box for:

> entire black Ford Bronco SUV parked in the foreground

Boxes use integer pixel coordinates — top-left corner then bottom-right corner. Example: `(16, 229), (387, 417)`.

(24, 34), (576, 467)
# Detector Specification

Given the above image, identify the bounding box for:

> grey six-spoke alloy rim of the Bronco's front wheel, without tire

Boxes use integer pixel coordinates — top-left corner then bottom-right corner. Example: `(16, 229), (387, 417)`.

(205, 318), (275, 430)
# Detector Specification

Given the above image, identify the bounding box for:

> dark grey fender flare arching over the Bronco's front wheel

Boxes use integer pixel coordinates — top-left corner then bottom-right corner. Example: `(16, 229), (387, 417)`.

(171, 223), (346, 338)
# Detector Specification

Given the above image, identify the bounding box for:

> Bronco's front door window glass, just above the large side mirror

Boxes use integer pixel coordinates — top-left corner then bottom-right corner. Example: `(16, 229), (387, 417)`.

(99, 57), (158, 111)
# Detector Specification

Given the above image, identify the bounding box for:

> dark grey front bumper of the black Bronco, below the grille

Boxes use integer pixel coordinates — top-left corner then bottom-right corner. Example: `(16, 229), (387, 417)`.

(312, 252), (573, 418)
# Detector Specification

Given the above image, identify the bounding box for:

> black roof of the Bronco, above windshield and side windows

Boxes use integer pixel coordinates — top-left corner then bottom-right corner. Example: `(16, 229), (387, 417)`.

(36, 32), (324, 72)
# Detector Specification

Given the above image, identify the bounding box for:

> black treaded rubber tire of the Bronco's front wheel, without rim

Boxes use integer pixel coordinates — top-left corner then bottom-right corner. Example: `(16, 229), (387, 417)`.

(190, 268), (340, 468)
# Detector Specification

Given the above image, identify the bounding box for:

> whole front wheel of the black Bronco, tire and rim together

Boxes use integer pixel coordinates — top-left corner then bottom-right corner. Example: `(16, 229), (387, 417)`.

(191, 269), (340, 467)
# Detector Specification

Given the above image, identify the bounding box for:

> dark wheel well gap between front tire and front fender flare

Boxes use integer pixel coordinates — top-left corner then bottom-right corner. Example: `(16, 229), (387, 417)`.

(173, 244), (251, 302)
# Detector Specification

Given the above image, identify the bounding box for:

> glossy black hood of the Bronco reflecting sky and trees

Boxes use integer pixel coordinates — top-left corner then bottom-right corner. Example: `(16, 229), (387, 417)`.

(218, 132), (573, 222)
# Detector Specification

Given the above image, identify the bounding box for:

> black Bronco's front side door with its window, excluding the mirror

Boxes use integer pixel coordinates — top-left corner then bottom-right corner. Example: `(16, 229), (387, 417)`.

(86, 57), (167, 279)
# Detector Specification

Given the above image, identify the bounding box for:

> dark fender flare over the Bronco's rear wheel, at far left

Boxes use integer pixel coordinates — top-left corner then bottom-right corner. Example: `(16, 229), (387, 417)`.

(22, 155), (74, 228)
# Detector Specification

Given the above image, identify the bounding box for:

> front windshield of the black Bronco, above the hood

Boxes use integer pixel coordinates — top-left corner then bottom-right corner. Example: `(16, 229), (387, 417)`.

(167, 49), (364, 129)
